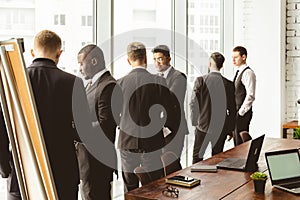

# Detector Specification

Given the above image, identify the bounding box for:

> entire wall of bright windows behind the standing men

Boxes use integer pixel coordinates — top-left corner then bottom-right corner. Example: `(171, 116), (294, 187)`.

(0, 0), (224, 199)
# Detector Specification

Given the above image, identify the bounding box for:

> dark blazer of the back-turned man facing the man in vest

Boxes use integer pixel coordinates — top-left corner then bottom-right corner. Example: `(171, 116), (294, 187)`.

(190, 72), (236, 134)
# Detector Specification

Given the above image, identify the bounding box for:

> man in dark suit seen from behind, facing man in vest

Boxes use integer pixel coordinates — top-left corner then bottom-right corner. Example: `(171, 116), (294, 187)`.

(190, 52), (236, 163)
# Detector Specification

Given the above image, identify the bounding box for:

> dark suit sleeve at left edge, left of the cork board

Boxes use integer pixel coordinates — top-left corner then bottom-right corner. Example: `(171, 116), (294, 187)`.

(0, 106), (11, 178)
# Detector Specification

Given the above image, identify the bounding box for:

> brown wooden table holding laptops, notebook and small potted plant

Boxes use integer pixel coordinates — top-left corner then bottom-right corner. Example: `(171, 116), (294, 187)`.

(125, 138), (300, 200)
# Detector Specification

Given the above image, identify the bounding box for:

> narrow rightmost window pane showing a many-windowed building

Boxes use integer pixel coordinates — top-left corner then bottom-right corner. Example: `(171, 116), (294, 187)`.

(180, 0), (222, 173)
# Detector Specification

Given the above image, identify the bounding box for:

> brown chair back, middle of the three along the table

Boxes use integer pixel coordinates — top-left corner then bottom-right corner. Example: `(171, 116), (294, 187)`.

(160, 151), (182, 176)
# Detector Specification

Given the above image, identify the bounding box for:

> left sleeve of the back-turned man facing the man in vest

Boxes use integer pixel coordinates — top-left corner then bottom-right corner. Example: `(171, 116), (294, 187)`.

(190, 78), (201, 126)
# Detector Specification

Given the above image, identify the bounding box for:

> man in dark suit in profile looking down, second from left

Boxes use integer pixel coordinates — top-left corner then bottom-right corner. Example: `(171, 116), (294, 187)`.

(77, 44), (122, 200)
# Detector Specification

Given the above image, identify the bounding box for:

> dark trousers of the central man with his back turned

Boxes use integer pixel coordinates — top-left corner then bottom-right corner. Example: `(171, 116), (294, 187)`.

(120, 149), (163, 192)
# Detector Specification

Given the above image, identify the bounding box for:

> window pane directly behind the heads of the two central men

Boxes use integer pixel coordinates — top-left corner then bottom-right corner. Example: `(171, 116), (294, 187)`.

(113, 0), (172, 78)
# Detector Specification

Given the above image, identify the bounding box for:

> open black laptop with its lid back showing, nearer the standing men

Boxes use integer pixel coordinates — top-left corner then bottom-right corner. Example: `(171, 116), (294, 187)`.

(217, 135), (265, 171)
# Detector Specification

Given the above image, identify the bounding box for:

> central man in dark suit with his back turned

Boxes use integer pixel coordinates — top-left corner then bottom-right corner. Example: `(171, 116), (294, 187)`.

(118, 42), (173, 192)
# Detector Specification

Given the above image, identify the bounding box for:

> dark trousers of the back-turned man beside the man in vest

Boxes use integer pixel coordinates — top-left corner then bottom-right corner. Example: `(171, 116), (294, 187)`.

(193, 128), (227, 164)
